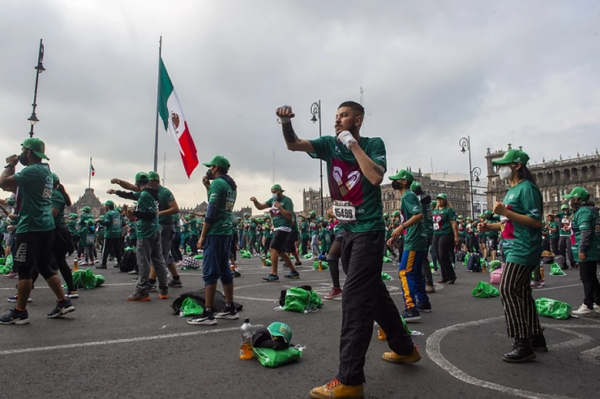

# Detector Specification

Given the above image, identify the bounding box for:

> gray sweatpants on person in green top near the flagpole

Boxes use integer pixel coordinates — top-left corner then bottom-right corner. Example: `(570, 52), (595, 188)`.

(136, 231), (168, 293)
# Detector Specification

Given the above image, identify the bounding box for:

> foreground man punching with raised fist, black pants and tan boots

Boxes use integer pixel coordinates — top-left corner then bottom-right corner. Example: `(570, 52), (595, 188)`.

(276, 101), (421, 398)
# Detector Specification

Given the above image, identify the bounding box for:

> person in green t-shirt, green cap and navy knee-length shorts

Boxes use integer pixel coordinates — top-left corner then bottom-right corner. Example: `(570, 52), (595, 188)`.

(187, 155), (239, 326)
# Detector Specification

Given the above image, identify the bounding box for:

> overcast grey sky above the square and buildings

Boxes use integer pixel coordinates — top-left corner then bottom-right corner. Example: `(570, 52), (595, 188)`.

(0, 0), (600, 209)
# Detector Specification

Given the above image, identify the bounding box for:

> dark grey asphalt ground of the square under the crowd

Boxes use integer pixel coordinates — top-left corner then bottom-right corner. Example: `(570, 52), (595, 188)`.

(0, 258), (600, 399)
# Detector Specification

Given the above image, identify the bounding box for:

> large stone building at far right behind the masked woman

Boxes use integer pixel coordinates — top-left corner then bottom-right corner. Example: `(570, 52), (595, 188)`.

(485, 144), (600, 213)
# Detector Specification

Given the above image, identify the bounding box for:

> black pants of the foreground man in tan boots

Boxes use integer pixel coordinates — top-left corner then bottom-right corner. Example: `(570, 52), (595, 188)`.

(337, 231), (414, 385)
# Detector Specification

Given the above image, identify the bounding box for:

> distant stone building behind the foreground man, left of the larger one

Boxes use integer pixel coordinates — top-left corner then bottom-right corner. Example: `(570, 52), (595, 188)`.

(302, 170), (471, 217)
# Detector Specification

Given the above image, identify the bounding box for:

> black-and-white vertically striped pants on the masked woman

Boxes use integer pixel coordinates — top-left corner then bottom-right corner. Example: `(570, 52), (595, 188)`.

(499, 263), (542, 339)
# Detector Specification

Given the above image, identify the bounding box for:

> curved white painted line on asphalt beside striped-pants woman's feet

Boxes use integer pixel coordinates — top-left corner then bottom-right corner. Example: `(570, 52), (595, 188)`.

(426, 316), (572, 399)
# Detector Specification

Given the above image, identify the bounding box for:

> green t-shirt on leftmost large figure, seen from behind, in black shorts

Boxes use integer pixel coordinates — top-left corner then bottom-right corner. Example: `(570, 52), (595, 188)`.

(13, 163), (54, 234)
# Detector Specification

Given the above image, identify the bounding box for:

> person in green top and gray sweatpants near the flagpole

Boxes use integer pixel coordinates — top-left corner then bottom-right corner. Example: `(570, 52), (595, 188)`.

(124, 172), (169, 302)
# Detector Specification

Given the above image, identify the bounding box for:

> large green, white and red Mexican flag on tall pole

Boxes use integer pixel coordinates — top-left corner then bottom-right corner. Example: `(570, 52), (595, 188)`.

(158, 58), (198, 179)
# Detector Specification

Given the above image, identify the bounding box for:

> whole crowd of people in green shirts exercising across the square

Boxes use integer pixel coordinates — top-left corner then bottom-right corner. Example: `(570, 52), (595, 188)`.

(0, 101), (600, 398)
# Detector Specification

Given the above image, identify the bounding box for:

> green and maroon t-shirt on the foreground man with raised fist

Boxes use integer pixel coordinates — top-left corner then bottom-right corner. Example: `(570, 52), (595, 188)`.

(310, 136), (387, 233)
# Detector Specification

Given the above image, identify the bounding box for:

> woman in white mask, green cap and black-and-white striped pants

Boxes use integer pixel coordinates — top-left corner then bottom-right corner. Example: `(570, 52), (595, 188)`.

(479, 149), (547, 363)
